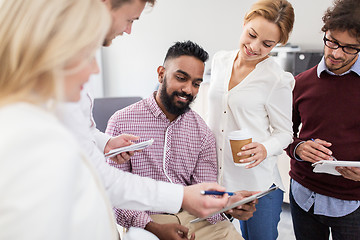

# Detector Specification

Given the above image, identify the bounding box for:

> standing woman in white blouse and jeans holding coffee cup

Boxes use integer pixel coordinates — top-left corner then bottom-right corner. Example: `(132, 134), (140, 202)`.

(209, 0), (294, 240)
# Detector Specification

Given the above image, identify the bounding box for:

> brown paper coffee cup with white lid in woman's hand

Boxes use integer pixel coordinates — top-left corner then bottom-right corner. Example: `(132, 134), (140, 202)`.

(228, 129), (252, 166)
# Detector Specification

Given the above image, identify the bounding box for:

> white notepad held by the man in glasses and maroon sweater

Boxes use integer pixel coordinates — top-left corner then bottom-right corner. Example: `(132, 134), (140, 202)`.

(312, 160), (360, 176)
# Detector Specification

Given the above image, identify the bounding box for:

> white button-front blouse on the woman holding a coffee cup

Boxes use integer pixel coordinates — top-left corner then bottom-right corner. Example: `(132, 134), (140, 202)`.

(208, 50), (295, 191)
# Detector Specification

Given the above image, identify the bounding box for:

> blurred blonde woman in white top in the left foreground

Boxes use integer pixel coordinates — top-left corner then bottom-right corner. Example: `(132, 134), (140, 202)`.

(0, 0), (118, 240)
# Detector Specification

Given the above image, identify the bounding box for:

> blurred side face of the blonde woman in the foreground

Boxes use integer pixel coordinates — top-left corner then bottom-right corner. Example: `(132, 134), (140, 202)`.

(64, 53), (99, 102)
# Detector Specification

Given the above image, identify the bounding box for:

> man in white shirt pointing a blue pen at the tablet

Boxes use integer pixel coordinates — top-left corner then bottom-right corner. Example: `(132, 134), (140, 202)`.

(59, 0), (255, 238)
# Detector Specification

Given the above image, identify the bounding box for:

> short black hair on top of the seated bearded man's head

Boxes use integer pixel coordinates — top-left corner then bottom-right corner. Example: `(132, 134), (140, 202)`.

(164, 41), (209, 63)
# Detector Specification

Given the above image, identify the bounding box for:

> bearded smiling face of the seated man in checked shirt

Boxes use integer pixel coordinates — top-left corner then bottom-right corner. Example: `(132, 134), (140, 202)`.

(156, 56), (204, 120)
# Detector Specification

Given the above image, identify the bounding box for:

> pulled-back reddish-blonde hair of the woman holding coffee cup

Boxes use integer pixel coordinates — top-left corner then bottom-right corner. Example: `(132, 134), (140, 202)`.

(244, 0), (295, 45)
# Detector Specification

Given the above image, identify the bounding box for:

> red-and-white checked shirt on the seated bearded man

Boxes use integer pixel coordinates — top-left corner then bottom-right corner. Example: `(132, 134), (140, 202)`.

(106, 96), (223, 228)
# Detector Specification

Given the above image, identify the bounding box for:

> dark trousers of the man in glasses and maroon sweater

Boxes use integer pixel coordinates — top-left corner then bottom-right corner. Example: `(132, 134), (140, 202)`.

(290, 190), (360, 240)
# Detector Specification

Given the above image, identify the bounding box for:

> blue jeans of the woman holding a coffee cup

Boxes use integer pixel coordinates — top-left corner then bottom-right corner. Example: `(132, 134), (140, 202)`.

(240, 186), (284, 240)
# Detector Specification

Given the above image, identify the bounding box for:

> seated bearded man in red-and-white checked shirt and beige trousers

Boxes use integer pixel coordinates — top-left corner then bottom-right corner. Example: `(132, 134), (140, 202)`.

(106, 41), (242, 240)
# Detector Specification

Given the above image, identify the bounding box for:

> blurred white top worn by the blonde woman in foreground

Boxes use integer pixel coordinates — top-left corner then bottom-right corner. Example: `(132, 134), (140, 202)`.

(0, 103), (118, 240)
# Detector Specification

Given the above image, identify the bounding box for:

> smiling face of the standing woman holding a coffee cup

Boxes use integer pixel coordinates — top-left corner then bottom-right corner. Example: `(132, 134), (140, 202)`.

(239, 16), (280, 62)
